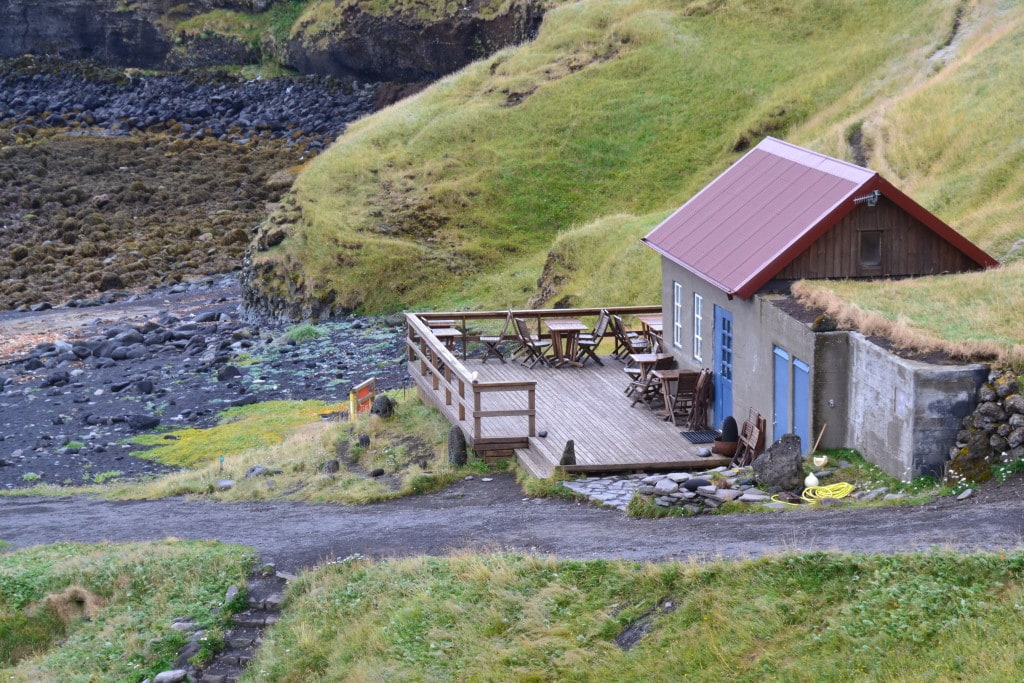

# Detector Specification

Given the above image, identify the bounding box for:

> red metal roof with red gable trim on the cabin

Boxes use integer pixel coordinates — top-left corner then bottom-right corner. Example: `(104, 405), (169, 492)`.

(643, 137), (996, 299)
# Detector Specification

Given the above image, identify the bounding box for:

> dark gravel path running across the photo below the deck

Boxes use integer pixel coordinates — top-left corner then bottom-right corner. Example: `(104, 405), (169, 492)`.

(0, 475), (1024, 571)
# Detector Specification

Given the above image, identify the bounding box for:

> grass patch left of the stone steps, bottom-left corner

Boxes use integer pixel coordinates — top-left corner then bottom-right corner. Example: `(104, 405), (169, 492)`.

(0, 541), (254, 681)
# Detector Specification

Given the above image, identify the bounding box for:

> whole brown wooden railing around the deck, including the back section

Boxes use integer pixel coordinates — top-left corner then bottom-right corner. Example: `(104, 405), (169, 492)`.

(406, 305), (662, 451)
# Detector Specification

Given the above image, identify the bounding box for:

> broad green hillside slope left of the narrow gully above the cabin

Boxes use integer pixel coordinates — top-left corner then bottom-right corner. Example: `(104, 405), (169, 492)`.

(256, 0), (952, 311)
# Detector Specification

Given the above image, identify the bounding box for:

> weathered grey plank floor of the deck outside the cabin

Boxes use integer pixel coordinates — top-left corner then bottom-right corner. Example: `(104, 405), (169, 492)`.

(415, 357), (729, 478)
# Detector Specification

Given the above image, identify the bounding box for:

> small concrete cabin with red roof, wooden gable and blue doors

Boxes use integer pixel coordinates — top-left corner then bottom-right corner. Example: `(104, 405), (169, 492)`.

(643, 137), (997, 477)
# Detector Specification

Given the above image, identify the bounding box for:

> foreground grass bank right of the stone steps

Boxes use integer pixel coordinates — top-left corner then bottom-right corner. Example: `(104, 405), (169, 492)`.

(250, 552), (1024, 683)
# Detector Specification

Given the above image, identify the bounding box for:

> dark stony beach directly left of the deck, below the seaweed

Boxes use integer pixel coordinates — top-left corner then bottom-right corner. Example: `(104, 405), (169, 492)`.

(0, 278), (406, 489)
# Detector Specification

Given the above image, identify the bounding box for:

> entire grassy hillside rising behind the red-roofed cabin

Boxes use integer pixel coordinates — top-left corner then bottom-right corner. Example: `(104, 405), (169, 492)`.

(247, 0), (1024, 362)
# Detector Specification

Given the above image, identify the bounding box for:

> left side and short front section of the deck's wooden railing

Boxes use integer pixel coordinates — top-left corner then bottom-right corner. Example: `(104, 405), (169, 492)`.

(406, 313), (537, 447)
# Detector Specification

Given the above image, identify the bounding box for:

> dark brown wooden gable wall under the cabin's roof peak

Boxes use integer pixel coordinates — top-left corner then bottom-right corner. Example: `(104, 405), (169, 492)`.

(775, 197), (981, 280)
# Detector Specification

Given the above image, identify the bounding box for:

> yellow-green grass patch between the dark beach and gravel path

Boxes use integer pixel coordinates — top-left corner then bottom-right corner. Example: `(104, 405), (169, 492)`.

(110, 392), (463, 504)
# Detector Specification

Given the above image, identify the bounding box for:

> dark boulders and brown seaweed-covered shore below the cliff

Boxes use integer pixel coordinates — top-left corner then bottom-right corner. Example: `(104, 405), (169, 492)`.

(0, 57), (378, 309)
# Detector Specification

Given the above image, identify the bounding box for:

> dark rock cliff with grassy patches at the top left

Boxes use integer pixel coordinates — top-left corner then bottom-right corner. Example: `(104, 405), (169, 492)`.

(0, 0), (542, 83)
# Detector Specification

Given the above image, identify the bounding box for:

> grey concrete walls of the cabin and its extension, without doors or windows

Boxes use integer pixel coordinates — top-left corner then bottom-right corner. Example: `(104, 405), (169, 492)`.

(662, 258), (989, 480)
